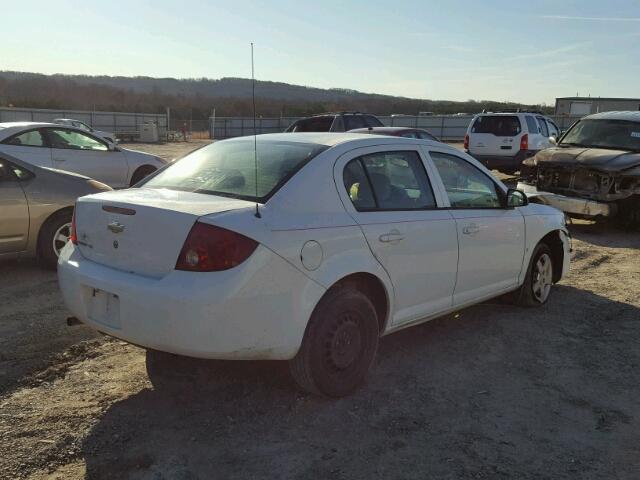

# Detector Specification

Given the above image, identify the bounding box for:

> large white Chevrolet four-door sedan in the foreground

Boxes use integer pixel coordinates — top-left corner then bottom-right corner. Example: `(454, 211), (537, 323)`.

(58, 133), (570, 396)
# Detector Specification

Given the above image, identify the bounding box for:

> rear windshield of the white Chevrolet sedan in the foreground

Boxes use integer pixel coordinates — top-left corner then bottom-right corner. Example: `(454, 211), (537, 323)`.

(143, 136), (327, 203)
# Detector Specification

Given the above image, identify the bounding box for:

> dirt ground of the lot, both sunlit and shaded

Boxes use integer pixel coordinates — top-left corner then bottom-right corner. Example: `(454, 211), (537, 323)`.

(0, 142), (640, 480)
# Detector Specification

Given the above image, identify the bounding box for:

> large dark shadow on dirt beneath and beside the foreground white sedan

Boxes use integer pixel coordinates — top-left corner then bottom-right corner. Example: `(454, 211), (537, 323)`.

(82, 286), (640, 479)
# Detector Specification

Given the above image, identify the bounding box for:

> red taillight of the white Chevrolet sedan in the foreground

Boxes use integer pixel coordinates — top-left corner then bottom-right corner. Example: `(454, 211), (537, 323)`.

(176, 222), (258, 272)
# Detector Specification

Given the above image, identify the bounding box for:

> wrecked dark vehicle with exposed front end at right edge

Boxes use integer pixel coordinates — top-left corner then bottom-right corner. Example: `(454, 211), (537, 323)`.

(520, 112), (640, 228)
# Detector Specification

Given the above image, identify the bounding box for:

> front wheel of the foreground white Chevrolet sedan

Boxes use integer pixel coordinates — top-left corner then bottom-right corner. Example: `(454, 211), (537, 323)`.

(510, 243), (561, 307)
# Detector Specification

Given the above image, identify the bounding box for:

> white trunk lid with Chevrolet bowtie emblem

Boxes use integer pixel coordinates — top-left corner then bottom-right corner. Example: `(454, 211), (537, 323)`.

(76, 188), (254, 278)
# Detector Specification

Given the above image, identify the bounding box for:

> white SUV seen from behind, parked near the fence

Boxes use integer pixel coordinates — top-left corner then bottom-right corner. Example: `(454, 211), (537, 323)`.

(464, 112), (560, 174)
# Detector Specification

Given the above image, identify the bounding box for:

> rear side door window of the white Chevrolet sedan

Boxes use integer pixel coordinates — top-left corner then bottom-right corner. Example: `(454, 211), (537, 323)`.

(344, 152), (436, 210)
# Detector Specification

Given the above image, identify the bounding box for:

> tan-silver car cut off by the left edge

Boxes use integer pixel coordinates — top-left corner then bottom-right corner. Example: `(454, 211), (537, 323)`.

(0, 153), (111, 268)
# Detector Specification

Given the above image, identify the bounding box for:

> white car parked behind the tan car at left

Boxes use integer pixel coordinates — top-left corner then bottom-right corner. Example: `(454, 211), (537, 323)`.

(0, 122), (167, 188)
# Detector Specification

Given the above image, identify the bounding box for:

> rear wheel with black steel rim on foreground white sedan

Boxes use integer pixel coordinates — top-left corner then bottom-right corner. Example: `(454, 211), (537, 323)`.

(289, 285), (380, 397)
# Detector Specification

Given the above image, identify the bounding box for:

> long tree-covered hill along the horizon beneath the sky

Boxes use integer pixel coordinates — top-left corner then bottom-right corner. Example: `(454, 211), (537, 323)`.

(0, 71), (552, 119)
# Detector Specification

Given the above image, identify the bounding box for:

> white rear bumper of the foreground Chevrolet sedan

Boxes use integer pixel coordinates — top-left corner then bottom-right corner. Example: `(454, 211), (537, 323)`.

(58, 244), (325, 360)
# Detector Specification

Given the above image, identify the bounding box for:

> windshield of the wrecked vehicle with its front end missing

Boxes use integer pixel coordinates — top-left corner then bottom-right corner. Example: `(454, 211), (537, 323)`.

(558, 119), (640, 151)
